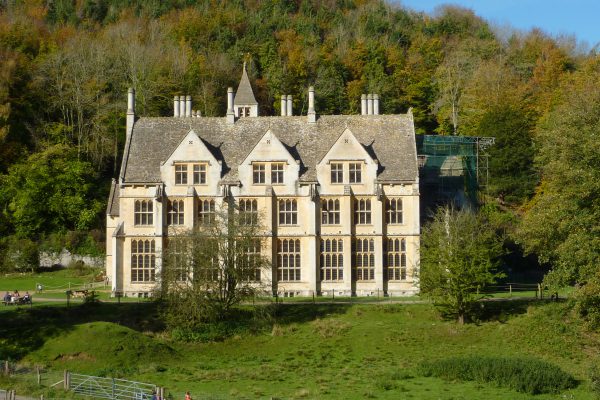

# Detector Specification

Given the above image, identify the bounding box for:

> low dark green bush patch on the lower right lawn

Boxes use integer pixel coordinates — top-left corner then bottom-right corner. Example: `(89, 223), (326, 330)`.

(419, 356), (577, 394)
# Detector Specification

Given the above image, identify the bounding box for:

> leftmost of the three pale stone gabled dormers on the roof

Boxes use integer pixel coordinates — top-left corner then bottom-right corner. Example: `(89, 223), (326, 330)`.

(160, 130), (221, 194)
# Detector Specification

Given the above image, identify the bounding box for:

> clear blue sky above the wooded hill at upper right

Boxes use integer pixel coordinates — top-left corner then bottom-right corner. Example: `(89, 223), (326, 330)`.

(392, 0), (600, 47)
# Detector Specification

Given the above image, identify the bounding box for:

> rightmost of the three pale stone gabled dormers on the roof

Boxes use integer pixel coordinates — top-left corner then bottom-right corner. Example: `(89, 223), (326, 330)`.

(317, 128), (378, 192)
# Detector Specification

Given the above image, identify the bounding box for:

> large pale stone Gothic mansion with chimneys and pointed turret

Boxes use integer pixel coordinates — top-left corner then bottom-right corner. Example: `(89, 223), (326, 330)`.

(106, 68), (420, 296)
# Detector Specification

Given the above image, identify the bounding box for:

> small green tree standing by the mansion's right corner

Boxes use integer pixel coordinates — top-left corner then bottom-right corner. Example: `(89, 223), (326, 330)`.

(420, 207), (502, 324)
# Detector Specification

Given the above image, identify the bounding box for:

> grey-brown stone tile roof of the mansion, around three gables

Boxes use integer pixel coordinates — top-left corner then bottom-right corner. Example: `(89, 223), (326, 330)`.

(122, 115), (418, 183)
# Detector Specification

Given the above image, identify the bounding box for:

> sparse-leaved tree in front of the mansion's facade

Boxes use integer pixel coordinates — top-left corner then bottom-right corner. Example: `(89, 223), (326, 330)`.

(158, 204), (269, 330)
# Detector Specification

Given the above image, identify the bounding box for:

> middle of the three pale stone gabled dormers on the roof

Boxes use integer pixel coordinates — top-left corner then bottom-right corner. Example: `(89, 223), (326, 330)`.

(238, 129), (300, 192)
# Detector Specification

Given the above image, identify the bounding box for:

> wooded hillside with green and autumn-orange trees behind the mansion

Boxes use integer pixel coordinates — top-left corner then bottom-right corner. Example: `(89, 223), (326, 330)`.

(0, 0), (600, 318)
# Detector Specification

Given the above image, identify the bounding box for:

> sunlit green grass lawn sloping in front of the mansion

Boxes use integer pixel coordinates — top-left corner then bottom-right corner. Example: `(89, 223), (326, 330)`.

(0, 301), (600, 400)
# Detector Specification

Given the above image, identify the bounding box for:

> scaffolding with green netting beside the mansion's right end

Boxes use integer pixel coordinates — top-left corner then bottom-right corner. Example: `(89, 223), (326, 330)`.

(416, 135), (494, 208)
